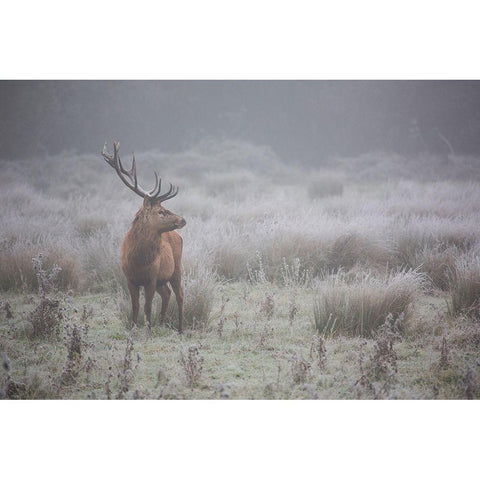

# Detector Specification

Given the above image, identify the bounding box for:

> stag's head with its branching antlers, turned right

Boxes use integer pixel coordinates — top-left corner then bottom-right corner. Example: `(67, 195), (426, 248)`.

(102, 142), (186, 234)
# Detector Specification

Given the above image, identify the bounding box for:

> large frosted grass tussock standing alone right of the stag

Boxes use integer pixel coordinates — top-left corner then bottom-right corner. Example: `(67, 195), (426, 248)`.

(314, 270), (425, 337)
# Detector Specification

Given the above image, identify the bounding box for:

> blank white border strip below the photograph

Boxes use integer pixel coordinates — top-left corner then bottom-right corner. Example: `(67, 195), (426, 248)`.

(0, 401), (480, 480)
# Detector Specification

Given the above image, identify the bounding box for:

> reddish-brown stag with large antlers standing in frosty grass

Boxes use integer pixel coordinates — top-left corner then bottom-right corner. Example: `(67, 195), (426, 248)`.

(101, 141), (186, 335)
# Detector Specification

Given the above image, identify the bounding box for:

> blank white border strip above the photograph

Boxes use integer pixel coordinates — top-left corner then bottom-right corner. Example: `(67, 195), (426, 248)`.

(0, 0), (480, 79)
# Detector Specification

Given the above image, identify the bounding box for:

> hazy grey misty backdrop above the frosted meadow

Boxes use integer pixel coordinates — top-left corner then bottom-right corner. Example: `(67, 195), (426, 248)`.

(0, 80), (480, 161)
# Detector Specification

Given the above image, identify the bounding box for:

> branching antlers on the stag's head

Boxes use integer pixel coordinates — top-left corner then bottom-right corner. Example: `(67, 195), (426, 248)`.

(102, 141), (178, 202)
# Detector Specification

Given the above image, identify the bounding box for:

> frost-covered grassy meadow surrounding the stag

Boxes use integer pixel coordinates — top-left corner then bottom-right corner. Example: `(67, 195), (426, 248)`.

(0, 140), (480, 399)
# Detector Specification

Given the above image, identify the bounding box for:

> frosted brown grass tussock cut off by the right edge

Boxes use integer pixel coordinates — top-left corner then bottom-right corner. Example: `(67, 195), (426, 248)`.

(448, 255), (480, 316)
